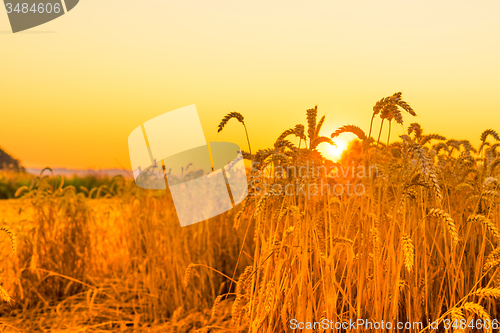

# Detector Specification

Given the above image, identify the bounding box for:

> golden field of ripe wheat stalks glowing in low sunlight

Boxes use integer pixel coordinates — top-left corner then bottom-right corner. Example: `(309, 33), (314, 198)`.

(0, 93), (500, 332)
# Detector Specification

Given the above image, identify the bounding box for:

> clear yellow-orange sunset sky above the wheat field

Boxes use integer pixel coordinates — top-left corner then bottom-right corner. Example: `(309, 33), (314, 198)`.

(0, 0), (500, 169)
